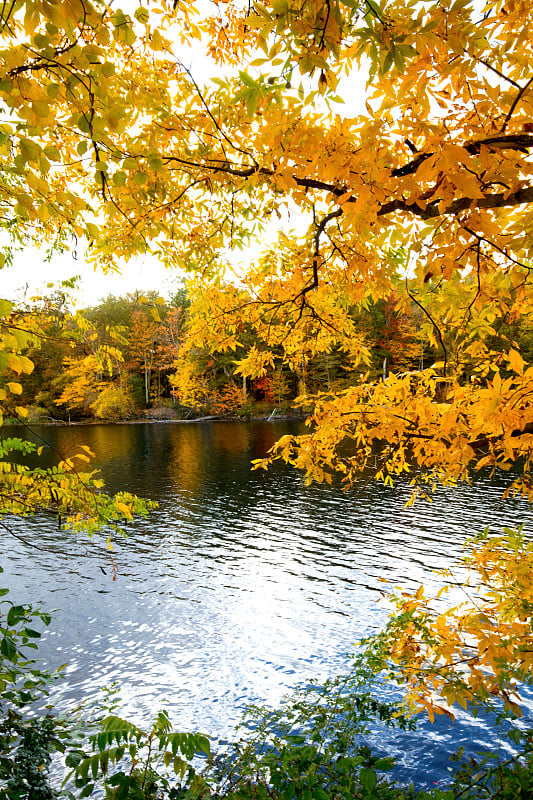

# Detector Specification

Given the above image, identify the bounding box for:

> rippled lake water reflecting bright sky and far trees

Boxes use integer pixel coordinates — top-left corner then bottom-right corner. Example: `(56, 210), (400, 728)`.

(0, 422), (531, 785)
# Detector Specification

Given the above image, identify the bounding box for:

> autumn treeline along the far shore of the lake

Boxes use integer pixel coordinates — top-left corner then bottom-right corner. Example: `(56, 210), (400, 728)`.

(12, 287), (533, 422)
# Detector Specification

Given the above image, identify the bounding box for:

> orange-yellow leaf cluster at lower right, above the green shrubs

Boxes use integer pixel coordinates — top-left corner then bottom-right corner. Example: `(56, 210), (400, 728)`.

(360, 529), (533, 722)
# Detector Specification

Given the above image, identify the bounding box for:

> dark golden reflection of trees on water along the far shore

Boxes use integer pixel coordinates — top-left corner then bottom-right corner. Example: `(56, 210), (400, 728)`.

(6, 422), (301, 503)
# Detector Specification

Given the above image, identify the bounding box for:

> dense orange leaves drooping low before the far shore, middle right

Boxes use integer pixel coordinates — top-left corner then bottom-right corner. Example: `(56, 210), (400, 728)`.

(256, 354), (533, 493)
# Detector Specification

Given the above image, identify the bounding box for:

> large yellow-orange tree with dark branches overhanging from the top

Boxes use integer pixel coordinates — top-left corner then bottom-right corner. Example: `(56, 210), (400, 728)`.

(0, 0), (533, 712)
